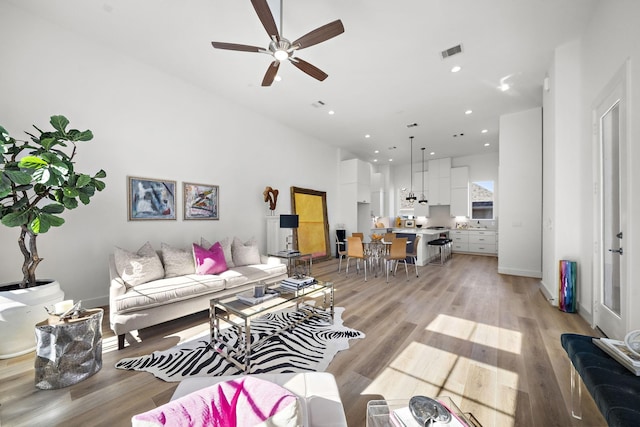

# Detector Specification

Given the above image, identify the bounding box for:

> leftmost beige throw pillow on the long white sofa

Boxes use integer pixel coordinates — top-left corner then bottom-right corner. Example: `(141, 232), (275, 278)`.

(113, 242), (164, 286)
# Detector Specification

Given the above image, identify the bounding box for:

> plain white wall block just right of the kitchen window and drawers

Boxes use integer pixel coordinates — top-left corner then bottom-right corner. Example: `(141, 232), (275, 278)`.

(498, 108), (542, 277)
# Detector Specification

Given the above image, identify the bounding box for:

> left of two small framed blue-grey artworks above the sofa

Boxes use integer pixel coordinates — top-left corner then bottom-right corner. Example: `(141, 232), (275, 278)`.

(127, 176), (176, 221)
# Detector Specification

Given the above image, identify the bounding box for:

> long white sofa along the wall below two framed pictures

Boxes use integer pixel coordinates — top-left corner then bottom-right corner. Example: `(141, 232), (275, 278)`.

(109, 239), (287, 349)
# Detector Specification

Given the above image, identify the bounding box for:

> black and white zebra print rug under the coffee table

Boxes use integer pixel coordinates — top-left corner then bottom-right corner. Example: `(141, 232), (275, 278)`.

(115, 307), (365, 382)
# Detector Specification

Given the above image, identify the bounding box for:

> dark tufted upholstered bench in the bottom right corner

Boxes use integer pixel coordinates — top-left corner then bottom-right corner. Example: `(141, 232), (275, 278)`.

(560, 334), (640, 427)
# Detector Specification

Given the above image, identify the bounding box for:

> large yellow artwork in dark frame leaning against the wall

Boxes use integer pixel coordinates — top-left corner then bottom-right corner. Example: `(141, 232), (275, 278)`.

(291, 187), (331, 259)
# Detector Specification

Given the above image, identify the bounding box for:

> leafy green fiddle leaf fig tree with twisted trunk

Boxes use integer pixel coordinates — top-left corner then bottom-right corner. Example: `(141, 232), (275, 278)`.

(0, 116), (107, 288)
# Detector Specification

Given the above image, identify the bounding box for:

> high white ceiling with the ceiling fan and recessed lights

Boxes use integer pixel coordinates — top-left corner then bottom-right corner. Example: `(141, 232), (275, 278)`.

(6, 0), (596, 164)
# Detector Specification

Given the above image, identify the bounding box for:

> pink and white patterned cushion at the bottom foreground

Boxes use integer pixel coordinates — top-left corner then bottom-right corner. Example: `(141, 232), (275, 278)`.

(131, 376), (302, 427)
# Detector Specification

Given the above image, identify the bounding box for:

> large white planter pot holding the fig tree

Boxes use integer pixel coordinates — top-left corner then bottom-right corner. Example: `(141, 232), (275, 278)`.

(0, 281), (64, 359)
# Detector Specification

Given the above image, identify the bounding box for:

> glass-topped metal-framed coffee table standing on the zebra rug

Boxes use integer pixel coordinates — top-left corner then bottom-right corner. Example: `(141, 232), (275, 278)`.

(209, 280), (334, 374)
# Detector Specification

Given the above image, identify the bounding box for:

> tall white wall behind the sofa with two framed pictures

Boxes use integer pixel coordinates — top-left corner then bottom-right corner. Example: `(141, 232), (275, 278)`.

(0, 2), (339, 306)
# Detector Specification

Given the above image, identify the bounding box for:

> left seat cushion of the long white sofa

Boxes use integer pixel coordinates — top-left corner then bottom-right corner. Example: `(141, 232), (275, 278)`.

(111, 274), (225, 314)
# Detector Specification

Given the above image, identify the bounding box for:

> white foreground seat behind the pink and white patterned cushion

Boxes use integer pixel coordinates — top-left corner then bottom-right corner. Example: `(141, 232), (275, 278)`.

(169, 372), (347, 427)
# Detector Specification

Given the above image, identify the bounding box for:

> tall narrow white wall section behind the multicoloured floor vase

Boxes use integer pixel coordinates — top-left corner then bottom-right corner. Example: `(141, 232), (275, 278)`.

(542, 41), (591, 305)
